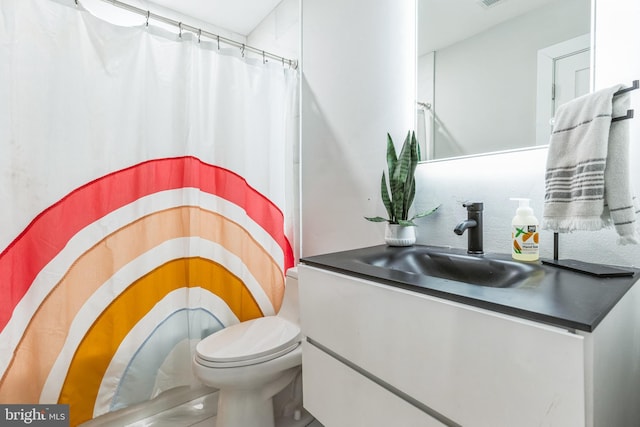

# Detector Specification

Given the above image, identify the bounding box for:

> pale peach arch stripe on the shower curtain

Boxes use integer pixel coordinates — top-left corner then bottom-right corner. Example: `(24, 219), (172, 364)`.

(0, 206), (284, 403)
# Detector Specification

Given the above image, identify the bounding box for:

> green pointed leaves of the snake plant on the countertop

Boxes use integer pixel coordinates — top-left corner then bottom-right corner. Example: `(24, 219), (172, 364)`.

(365, 132), (440, 226)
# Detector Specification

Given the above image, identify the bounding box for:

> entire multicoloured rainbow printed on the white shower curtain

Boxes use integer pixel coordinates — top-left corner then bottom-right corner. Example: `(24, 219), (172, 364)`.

(0, 157), (293, 421)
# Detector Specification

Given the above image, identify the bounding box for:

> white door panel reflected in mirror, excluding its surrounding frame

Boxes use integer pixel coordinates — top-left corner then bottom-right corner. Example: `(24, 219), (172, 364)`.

(552, 49), (591, 114)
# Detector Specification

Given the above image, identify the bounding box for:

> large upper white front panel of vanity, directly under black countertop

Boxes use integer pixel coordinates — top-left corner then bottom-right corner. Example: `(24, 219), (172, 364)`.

(299, 266), (585, 427)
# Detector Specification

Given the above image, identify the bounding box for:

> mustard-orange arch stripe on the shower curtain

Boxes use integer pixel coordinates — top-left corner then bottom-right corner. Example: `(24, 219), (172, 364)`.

(59, 258), (262, 425)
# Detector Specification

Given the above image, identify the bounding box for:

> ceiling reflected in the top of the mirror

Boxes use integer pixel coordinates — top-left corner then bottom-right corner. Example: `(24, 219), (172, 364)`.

(417, 0), (562, 55)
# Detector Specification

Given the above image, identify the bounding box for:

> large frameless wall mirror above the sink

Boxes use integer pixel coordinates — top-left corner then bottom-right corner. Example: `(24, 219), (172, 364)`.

(416, 0), (591, 160)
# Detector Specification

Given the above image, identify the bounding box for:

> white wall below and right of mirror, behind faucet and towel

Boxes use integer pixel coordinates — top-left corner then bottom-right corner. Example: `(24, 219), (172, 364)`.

(416, 0), (640, 267)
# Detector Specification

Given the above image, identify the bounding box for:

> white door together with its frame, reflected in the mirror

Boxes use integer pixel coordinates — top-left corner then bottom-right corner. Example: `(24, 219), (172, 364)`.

(536, 34), (592, 145)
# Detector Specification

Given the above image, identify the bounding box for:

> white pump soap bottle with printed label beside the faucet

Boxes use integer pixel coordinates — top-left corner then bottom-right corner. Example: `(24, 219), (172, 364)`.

(511, 198), (540, 261)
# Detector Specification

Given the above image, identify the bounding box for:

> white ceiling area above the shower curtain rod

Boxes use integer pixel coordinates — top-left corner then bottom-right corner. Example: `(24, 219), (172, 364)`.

(149, 0), (281, 36)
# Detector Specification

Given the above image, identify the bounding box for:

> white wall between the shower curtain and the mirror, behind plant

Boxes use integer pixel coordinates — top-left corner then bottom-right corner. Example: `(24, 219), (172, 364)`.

(301, 0), (416, 256)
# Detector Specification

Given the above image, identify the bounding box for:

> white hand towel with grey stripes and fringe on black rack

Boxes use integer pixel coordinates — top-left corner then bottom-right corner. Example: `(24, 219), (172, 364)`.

(542, 85), (639, 244)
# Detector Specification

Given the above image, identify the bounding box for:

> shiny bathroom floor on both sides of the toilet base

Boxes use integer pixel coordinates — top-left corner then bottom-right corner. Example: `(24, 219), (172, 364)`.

(82, 391), (323, 427)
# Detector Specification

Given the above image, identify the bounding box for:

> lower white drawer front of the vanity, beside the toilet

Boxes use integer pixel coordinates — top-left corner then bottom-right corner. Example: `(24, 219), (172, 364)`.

(302, 342), (444, 427)
